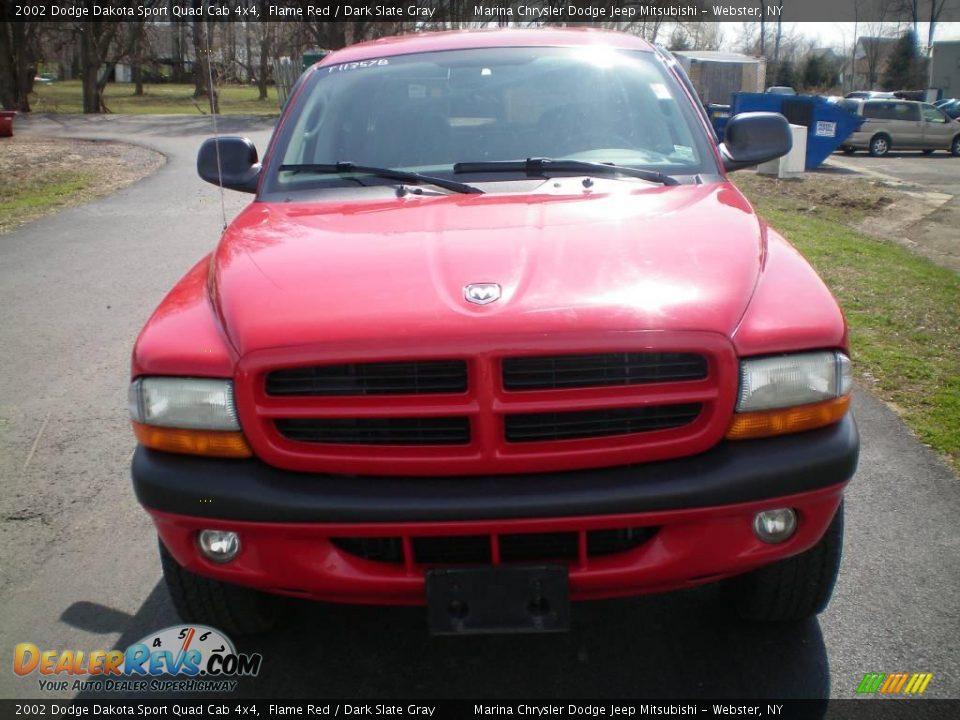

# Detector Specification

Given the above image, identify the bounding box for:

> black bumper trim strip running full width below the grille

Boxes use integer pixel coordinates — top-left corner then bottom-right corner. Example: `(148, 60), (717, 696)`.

(132, 415), (860, 522)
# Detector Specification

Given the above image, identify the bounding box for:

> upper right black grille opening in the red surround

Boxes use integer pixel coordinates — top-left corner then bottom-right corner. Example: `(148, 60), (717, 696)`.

(503, 352), (707, 390)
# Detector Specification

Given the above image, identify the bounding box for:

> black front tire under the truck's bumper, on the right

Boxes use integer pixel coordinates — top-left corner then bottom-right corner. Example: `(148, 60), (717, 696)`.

(729, 505), (843, 623)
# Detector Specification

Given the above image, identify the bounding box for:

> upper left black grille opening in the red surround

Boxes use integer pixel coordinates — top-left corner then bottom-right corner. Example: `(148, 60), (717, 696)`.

(267, 360), (467, 396)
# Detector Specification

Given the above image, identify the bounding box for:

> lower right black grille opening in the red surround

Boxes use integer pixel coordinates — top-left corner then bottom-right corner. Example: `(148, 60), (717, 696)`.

(504, 403), (700, 442)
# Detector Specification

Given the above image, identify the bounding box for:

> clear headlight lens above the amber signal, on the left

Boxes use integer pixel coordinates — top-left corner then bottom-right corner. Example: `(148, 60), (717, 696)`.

(129, 377), (240, 430)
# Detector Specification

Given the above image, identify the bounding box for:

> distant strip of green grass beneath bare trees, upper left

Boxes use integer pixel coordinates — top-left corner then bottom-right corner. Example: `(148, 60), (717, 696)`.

(30, 80), (280, 115)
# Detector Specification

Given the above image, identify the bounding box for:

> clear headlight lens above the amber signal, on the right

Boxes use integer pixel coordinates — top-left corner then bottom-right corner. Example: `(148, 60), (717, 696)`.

(737, 352), (852, 412)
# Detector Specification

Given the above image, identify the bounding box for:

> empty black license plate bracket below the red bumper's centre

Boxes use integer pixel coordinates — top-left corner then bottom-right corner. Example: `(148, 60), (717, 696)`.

(426, 565), (570, 635)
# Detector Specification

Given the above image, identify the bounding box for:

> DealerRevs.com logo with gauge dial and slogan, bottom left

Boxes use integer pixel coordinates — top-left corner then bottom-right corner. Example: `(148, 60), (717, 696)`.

(13, 625), (263, 692)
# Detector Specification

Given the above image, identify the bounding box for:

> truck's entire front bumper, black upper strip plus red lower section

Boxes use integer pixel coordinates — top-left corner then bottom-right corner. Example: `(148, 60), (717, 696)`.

(133, 416), (859, 604)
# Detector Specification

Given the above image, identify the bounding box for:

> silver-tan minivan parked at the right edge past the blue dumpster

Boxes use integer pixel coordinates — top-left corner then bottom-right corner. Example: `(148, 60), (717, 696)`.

(838, 98), (960, 157)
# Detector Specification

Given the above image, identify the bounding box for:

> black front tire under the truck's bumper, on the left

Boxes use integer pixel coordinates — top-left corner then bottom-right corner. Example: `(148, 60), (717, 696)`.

(160, 542), (278, 635)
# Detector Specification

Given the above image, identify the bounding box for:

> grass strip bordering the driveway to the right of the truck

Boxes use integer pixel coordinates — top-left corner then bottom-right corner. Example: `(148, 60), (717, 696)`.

(732, 173), (960, 471)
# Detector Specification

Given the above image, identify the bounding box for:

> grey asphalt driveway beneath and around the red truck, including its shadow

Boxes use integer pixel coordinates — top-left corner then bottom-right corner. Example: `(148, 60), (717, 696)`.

(0, 117), (960, 698)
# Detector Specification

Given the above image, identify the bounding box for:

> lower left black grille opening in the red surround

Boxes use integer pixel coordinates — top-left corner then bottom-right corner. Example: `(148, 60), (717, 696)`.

(276, 417), (470, 445)
